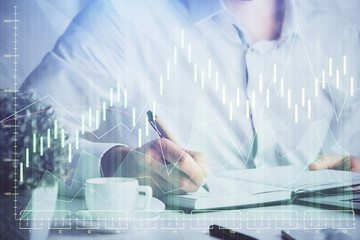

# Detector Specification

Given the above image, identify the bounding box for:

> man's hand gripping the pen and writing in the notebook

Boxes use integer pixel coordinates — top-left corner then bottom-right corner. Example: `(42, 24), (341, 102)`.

(102, 138), (206, 198)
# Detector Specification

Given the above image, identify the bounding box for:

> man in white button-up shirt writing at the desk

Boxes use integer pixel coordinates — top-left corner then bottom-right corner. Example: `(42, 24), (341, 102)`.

(22, 0), (360, 196)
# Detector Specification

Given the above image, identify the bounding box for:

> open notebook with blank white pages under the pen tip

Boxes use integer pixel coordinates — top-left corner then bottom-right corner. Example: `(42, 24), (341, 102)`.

(165, 166), (360, 209)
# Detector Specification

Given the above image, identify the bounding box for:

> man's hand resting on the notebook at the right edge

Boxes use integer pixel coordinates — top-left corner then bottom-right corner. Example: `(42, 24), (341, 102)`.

(309, 155), (360, 172)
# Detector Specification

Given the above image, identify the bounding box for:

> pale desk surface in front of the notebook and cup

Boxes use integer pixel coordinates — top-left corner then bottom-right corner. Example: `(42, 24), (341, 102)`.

(48, 197), (360, 240)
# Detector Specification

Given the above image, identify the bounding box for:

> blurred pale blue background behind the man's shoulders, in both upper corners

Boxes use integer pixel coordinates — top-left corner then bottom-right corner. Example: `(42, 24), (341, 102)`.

(0, 0), (360, 88)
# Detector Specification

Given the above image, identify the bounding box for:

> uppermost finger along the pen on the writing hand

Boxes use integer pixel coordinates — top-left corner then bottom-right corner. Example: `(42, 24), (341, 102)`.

(152, 138), (205, 187)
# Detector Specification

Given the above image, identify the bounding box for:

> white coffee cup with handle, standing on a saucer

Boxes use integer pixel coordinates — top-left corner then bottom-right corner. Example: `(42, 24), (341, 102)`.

(85, 177), (152, 219)
